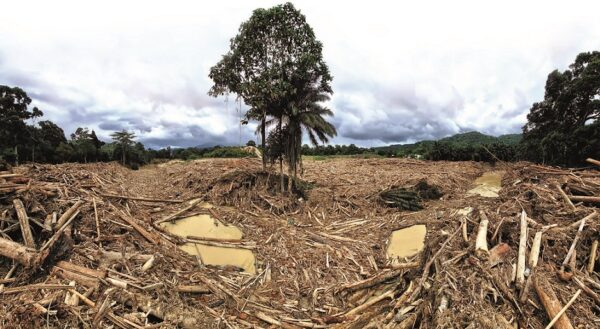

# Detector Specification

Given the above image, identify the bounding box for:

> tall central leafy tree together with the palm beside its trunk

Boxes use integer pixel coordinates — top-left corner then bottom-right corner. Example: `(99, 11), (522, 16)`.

(209, 3), (335, 188)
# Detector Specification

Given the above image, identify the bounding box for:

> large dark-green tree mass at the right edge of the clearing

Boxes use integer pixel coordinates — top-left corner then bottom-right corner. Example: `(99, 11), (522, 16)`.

(522, 51), (600, 165)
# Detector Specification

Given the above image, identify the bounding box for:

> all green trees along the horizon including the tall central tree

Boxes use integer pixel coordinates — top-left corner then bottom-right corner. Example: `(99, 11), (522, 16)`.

(0, 3), (600, 169)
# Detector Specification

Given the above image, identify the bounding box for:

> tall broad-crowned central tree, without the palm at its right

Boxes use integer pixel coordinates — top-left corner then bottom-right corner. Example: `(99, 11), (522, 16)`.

(209, 2), (331, 168)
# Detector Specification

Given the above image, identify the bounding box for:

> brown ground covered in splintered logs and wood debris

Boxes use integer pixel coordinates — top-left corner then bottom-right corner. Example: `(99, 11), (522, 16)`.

(0, 159), (600, 328)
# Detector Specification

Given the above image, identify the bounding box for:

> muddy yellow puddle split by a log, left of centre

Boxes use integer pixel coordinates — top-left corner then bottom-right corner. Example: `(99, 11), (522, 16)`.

(160, 205), (256, 274)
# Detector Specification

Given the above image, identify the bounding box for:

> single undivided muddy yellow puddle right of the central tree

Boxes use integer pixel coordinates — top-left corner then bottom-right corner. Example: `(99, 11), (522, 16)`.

(387, 225), (427, 262)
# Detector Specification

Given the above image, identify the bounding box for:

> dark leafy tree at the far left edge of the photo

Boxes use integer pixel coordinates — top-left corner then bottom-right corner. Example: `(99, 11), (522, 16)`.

(0, 85), (43, 164)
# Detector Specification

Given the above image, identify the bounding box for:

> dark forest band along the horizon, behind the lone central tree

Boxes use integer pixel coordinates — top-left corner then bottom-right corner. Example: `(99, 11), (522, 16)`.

(0, 52), (600, 168)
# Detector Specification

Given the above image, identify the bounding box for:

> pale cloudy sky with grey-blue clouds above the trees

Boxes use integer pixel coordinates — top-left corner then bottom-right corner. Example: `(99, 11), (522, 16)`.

(0, 0), (600, 147)
